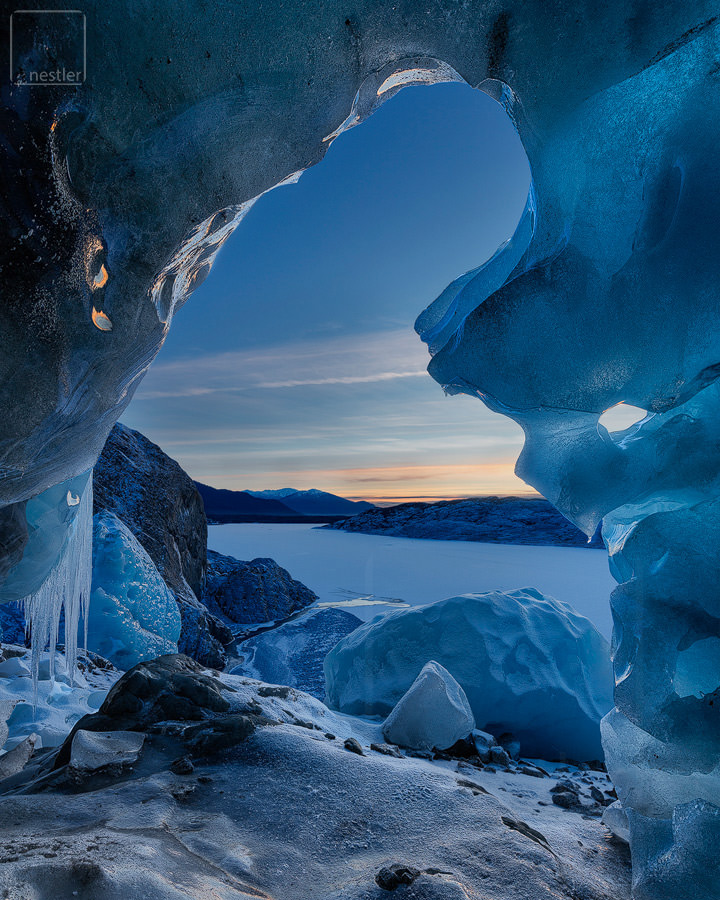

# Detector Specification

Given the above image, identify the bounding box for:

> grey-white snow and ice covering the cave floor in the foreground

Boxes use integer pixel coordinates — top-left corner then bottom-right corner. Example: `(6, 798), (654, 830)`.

(0, 673), (629, 900)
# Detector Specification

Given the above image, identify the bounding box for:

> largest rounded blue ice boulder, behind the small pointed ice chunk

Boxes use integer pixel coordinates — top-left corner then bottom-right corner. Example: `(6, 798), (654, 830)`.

(325, 588), (613, 760)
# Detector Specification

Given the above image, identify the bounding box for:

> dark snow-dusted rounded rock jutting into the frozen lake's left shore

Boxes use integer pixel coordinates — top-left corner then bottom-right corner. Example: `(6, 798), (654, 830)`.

(203, 550), (317, 624)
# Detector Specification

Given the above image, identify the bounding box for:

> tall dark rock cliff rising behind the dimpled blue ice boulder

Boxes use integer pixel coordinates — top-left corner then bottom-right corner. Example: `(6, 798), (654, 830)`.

(93, 424), (232, 669)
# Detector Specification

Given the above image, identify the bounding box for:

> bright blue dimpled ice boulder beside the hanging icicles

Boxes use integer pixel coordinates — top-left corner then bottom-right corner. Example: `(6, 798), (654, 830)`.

(88, 510), (180, 669)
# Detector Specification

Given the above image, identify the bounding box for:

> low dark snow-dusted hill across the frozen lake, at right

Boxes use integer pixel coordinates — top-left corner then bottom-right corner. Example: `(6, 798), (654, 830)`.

(325, 497), (604, 549)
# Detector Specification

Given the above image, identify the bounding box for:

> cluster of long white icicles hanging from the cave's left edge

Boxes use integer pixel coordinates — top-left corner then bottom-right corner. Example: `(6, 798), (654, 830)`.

(24, 474), (93, 696)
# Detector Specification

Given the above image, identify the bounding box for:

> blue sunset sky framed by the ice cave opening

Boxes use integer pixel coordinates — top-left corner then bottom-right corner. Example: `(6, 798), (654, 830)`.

(122, 84), (530, 503)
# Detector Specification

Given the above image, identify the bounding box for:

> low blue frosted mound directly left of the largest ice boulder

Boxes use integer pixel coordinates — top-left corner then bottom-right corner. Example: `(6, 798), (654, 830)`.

(232, 609), (362, 700)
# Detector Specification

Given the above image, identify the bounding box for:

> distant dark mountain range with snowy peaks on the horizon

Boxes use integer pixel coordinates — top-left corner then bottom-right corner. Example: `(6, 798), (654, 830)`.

(195, 481), (375, 522)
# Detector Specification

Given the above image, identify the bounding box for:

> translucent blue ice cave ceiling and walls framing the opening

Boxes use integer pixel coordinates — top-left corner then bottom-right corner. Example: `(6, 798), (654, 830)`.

(0, 0), (720, 900)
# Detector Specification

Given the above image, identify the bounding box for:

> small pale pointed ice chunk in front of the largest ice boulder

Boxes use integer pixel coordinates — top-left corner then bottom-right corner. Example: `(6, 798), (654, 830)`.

(383, 660), (475, 750)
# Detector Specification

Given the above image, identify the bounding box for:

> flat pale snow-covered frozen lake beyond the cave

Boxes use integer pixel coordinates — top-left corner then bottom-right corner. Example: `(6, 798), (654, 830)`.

(208, 524), (615, 638)
